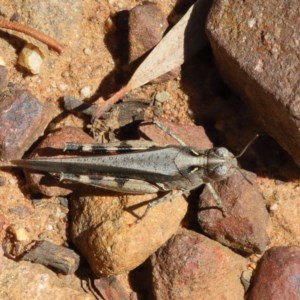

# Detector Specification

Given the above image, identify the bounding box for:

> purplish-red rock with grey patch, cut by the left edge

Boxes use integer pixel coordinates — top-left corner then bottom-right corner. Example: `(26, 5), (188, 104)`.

(0, 90), (57, 161)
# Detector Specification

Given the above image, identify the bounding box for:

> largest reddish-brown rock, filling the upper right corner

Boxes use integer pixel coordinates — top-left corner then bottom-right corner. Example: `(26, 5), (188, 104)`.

(207, 0), (300, 165)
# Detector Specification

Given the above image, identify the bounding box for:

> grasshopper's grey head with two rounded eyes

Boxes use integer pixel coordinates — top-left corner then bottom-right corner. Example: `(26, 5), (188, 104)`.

(206, 147), (238, 181)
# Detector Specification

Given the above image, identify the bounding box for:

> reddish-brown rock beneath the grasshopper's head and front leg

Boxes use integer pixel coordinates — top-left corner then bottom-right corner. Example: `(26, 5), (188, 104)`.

(198, 171), (269, 253)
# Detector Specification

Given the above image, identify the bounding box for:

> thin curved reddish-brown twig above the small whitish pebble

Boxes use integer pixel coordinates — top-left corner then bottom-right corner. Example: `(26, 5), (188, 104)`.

(0, 19), (63, 54)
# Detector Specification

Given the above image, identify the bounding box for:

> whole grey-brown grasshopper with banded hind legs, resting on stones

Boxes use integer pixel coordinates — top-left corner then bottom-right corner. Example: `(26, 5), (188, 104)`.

(12, 121), (253, 214)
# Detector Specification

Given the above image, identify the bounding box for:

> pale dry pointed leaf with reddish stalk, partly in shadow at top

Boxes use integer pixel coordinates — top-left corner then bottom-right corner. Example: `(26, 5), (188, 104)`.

(93, 0), (211, 119)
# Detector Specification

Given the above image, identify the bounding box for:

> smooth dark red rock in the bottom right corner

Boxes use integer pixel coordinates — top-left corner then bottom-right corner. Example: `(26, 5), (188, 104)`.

(247, 246), (300, 300)
